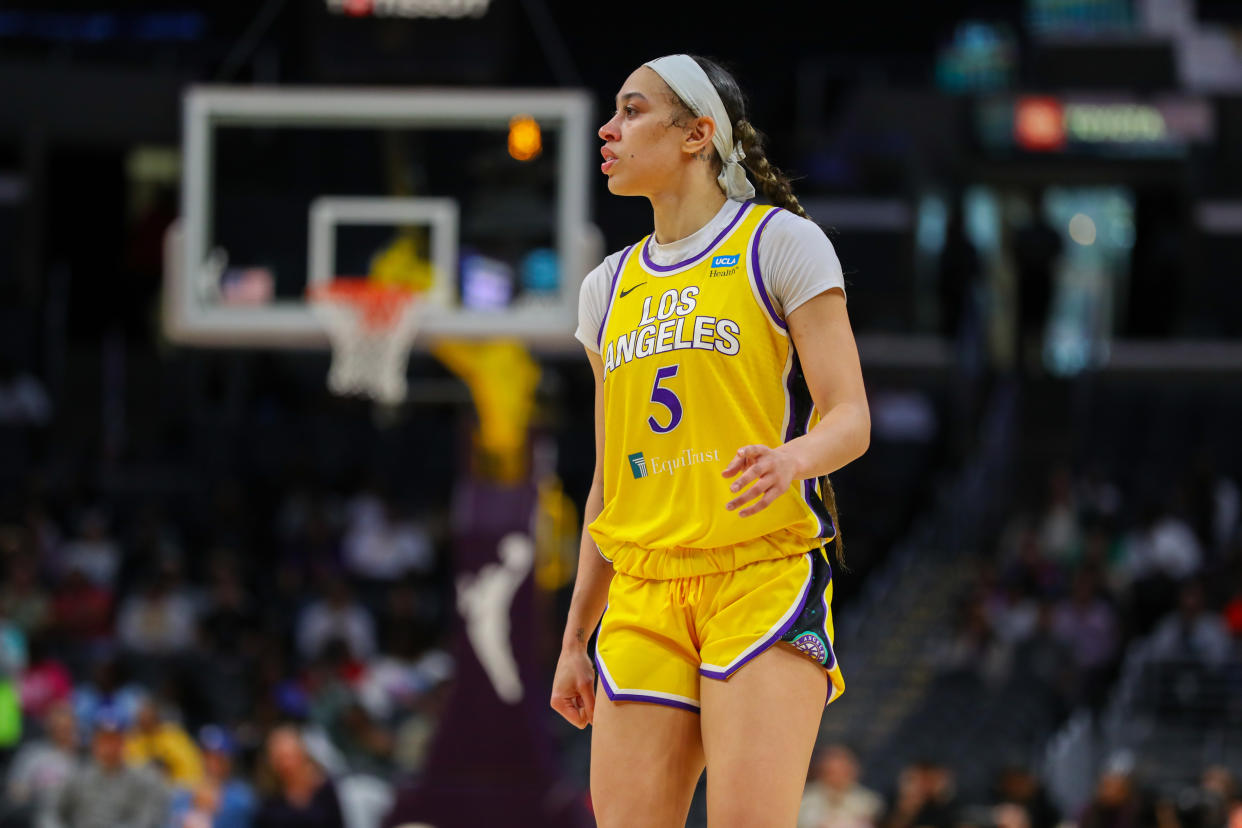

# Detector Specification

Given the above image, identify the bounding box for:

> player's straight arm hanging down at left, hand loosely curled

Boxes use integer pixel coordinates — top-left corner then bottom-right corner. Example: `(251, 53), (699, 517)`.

(551, 349), (612, 729)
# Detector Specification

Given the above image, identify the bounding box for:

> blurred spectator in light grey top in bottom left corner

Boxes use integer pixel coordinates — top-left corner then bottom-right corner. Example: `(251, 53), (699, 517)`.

(0, 703), (78, 823)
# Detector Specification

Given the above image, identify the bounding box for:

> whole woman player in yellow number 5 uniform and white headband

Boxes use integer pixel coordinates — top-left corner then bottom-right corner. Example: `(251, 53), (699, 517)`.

(551, 55), (871, 828)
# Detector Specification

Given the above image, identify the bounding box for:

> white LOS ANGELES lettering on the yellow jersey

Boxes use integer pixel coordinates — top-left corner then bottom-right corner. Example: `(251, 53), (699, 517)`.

(604, 284), (741, 375)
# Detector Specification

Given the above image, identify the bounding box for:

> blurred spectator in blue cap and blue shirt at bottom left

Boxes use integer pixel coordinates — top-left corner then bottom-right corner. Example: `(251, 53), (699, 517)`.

(170, 725), (258, 828)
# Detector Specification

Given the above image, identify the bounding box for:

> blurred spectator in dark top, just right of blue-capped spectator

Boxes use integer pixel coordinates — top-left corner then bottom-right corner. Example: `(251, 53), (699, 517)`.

(255, 726), (345, 828)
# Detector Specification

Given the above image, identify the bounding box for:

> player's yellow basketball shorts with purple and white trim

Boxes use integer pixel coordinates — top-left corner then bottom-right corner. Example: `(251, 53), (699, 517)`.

(595, 549), (845, 713)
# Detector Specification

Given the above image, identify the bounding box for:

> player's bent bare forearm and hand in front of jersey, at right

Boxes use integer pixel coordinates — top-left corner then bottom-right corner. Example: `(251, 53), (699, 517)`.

(723, 288), (871, 518)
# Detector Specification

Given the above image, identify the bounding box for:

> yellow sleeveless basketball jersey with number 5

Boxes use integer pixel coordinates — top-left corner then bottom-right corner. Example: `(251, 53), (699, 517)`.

(590, 204), (835, 577)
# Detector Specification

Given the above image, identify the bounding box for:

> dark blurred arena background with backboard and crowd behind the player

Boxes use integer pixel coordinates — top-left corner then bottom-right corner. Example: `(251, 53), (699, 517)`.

(0, 0), (1242, 828)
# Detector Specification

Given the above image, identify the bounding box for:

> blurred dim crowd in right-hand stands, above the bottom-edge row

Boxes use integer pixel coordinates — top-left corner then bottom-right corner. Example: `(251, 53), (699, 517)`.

(936, 459), (1242, 713)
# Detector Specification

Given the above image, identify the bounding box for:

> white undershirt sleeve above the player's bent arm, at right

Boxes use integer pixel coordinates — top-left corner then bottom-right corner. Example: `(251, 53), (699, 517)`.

(759, 210), (846, 318)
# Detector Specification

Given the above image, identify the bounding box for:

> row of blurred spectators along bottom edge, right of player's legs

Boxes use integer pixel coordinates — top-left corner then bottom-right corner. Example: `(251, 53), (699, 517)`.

(797, 745), (1242, 828)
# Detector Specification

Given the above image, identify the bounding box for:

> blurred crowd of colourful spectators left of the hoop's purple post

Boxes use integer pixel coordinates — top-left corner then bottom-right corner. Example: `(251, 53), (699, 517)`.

(0, 485), (453, 828)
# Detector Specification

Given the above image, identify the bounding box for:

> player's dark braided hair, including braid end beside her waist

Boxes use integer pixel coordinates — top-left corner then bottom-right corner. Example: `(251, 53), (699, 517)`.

(671, 55), (845, 565)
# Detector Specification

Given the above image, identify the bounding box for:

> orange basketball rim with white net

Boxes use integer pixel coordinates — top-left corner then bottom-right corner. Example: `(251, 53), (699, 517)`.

(309, 278), (421, 405)
